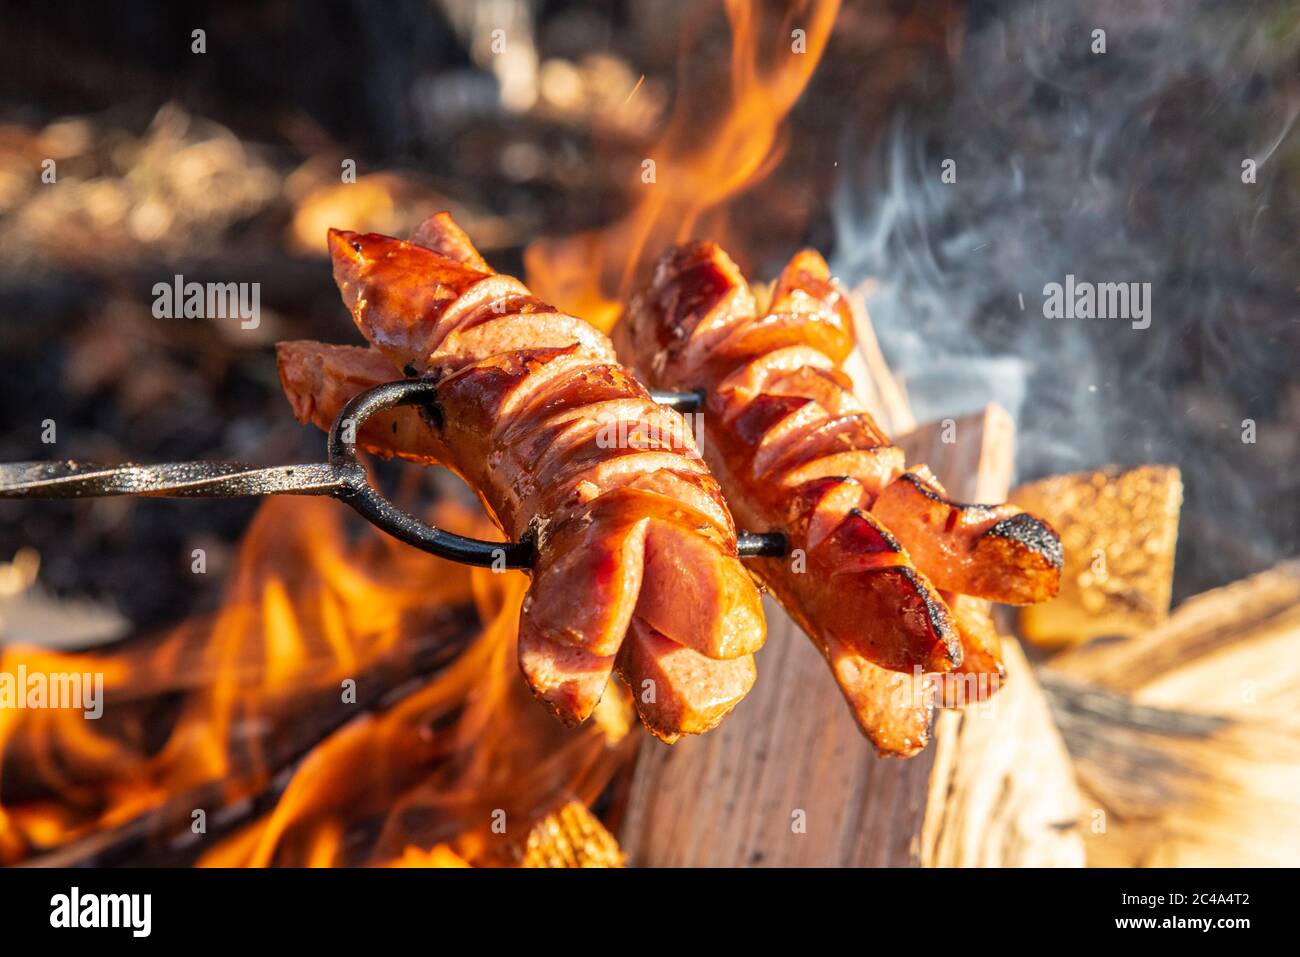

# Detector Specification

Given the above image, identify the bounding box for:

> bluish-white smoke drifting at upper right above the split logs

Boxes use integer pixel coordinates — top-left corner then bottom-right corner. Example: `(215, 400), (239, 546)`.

(832, 0), (1300, 595)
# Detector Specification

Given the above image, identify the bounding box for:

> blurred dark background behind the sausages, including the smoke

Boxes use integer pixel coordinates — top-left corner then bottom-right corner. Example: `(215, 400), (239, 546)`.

(0, 0), (1300, 627)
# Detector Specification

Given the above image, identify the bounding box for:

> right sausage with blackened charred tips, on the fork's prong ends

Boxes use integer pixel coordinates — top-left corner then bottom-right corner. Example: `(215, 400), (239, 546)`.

(615, 243), (1061, 754)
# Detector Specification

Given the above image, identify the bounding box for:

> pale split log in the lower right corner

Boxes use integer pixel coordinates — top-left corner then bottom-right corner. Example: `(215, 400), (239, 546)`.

(1043, 560), (1300, 867)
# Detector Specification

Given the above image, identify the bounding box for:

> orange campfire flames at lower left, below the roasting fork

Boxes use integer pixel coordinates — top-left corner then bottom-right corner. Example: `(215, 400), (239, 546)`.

(0, 499), (629, 866)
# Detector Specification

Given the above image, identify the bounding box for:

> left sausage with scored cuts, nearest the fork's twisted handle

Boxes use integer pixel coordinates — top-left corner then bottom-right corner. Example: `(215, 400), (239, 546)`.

(280, 213), (764, 740)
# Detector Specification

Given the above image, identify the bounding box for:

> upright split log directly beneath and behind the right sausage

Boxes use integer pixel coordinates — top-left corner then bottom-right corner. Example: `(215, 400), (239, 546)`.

(620, 397), (1083, 866)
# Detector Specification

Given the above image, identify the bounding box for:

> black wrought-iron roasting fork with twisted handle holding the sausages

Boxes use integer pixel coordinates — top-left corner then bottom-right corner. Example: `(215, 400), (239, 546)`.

(0, 378), (787, 568)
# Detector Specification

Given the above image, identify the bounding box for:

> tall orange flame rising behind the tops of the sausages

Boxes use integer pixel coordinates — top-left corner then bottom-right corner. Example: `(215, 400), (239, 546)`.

(524, 0), (840, 332)
